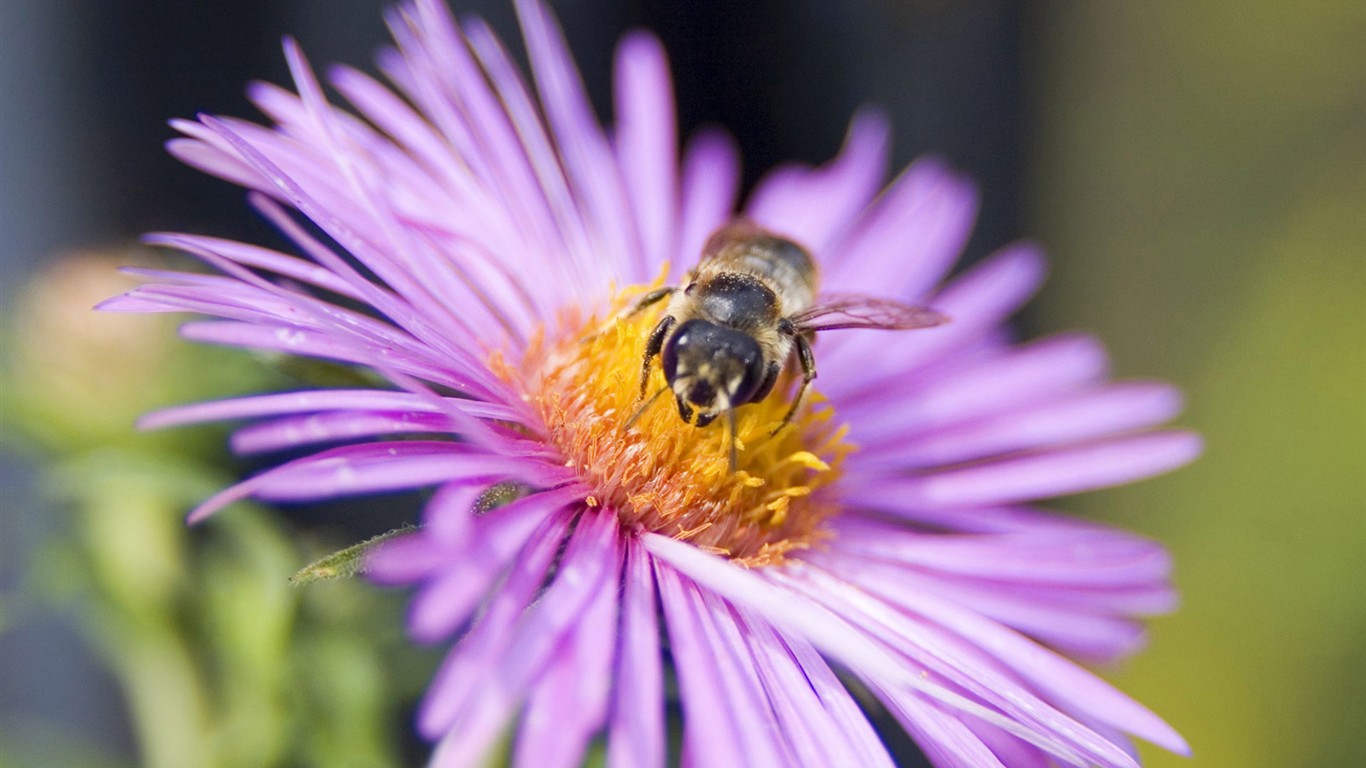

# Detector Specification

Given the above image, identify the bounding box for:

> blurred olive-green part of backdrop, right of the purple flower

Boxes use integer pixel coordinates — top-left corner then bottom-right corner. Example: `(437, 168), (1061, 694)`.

(1022, 0), (1366, 767)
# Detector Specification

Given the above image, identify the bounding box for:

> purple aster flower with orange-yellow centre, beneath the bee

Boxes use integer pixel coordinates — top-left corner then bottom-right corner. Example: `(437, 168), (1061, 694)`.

(107, 0), (1199, 767)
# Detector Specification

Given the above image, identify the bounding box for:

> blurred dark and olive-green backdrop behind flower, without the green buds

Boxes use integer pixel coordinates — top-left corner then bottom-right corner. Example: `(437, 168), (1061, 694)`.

(0, 0), (1366, 767)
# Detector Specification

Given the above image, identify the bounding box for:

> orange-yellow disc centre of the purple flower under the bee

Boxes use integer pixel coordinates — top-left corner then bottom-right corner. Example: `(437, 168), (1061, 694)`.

(508, 286), (852, 566)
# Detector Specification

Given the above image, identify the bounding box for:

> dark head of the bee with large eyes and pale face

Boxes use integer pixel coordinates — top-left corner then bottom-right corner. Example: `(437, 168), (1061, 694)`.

(661, 320), (766, 426)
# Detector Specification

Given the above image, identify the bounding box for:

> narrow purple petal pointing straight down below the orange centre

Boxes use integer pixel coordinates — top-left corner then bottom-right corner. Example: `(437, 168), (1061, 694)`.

(607, 543), (665, 768)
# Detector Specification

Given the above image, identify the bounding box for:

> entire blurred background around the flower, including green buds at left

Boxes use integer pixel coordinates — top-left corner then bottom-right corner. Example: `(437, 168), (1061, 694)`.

(0, 0), (1366, 768)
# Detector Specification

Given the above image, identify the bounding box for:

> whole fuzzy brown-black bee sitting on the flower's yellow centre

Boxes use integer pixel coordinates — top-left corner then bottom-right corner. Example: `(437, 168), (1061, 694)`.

(627, 219), (948, 471)
